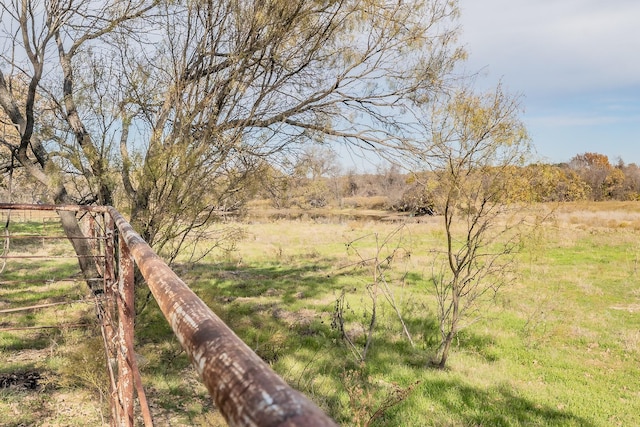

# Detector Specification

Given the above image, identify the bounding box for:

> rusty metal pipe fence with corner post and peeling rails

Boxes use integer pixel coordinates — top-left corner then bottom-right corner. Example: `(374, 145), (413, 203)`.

(0, 203), (336, 427)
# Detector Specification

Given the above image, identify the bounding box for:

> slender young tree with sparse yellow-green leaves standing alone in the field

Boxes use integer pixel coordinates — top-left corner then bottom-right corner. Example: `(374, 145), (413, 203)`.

(422, 87), (529, 368)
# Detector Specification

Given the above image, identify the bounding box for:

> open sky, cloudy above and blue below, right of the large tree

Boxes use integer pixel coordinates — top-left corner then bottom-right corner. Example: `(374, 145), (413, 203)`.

(459, 0), (640, 165)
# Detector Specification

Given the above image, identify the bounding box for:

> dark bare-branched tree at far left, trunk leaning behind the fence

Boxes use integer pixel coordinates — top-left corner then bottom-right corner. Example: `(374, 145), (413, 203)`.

(0, 0), (155, 290)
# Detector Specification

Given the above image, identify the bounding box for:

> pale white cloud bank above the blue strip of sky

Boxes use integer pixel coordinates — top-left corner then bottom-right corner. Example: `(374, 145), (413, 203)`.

(460, 0), (640, 96)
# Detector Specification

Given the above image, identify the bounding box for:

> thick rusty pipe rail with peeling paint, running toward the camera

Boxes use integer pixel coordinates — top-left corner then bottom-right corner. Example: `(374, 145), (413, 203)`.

(108, 207), (336, 427)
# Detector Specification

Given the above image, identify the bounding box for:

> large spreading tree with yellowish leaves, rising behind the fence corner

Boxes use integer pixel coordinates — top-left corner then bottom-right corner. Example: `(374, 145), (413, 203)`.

(116, 1), (462, 252)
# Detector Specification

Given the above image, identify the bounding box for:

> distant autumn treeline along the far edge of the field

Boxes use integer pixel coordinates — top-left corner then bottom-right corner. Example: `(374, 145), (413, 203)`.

(254, 150), (640, 214)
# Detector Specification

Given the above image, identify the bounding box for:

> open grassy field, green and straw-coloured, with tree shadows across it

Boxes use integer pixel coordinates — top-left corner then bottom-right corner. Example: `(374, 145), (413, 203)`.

(0, 202), (640, 426)
